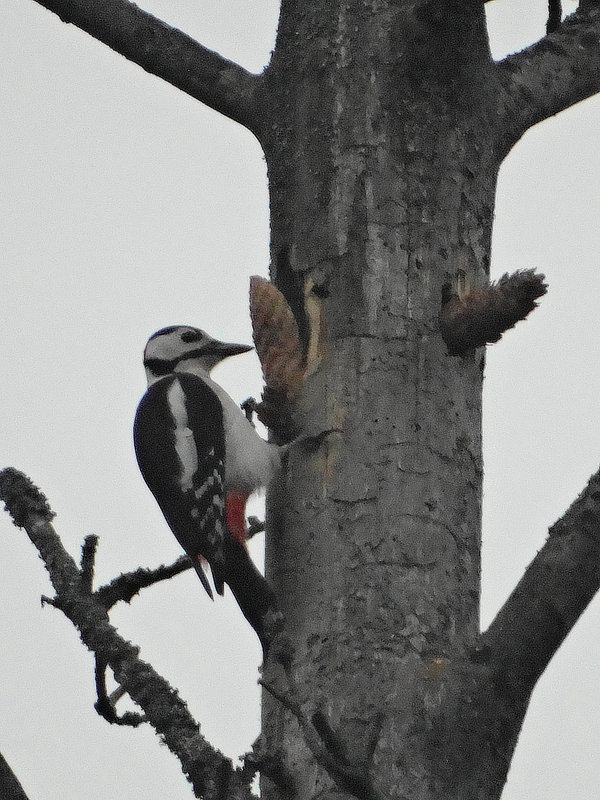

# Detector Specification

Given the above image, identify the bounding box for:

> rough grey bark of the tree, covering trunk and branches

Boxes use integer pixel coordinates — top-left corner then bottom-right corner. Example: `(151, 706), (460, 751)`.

(5, 0), (600, 800)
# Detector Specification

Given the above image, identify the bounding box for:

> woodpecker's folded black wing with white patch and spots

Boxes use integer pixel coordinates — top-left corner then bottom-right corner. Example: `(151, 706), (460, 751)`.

(133, 374), (226, 596)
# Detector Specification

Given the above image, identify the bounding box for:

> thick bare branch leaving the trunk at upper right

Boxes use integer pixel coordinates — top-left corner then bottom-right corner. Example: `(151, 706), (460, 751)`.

(497, 3), (600, 152)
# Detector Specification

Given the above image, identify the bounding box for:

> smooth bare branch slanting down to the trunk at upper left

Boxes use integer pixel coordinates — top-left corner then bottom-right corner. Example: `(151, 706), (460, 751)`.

(28, 0), (264, 130)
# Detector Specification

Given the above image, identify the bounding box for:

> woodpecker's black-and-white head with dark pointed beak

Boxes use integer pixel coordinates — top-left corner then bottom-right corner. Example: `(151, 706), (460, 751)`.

(144, 325), (252, 385)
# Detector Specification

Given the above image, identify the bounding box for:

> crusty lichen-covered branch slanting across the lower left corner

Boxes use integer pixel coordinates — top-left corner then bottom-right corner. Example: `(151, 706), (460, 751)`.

(0, 468), (253, 800)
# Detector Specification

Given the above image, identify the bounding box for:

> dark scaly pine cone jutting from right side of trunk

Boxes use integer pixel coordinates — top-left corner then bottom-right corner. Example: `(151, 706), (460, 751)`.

(440, 269), (548, 355)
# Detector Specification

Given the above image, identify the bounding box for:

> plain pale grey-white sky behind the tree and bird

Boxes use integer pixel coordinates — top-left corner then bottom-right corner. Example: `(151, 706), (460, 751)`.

(0, 0), (600, 800)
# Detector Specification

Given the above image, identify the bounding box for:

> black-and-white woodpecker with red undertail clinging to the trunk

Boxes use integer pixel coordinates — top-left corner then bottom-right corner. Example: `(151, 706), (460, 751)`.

(133, 325), (283, 649)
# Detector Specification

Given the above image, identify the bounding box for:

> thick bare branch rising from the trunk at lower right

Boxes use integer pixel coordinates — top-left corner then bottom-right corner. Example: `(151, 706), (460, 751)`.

(480, 470), (600, 697)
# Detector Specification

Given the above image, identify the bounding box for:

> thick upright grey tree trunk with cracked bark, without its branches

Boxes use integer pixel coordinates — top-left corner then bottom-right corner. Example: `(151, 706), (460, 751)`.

(261, 0), (514, 800)
